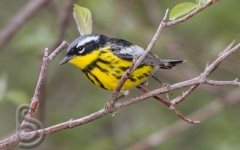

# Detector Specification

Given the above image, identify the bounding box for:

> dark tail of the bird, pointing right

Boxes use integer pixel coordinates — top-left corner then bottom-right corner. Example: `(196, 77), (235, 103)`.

(159, 59), (186, 69)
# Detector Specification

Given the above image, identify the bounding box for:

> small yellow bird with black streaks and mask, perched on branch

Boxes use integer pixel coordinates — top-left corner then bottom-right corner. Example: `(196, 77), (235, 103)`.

(60, 34), (184, 93)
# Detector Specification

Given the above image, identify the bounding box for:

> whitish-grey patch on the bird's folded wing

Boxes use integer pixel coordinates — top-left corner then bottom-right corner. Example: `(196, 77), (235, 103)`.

(119, 45), (144, 56)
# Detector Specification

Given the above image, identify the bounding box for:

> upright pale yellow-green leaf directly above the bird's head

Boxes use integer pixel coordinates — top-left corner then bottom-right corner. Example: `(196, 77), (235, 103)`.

(73, 4), (92, 35)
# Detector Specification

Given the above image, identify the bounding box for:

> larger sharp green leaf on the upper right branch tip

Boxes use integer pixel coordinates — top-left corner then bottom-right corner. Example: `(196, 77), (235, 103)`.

(169, 2), (199, 20)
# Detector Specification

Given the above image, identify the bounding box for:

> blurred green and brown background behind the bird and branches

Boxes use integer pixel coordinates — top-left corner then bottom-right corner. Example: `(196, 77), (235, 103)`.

(0, 0), (240, 150)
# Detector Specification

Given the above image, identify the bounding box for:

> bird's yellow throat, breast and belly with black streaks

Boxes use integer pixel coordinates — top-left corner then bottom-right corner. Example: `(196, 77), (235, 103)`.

(69, 47), (153, 90)
